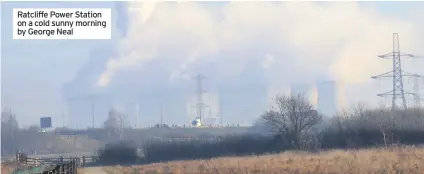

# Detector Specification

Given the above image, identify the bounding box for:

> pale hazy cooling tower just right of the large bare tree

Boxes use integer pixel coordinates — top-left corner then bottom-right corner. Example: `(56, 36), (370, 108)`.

(317, 81), (337, 116)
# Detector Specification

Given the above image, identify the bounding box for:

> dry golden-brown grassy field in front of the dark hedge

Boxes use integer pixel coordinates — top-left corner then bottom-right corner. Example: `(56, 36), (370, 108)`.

(100, 147), (424, 174)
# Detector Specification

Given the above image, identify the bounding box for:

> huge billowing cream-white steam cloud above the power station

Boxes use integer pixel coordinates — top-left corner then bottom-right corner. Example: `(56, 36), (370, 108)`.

(97, 2), (422, 92)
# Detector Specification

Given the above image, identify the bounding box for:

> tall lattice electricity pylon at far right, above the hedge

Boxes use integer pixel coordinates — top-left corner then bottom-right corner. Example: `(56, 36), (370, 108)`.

(371, 33), (416, 110)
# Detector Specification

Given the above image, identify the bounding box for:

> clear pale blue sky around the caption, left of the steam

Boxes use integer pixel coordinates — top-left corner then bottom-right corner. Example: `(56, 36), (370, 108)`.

(1, 2), (424, 126)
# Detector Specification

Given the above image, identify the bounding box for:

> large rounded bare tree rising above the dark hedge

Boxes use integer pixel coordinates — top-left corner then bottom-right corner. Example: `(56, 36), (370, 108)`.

(261, 95), (322, 148)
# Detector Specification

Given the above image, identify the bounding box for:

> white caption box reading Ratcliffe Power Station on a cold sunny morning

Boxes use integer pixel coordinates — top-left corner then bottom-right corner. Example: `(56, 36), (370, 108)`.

(13, 8), (112, 39)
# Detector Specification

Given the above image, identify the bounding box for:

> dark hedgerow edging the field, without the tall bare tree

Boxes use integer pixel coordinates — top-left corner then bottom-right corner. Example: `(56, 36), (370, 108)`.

(96, 106), (424, 163)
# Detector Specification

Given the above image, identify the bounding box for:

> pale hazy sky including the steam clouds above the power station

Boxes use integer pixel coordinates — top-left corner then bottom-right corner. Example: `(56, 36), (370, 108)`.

(1, 2), (424, 128)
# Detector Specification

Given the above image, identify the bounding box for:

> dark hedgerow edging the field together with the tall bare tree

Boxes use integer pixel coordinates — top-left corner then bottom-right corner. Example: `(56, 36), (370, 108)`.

(96, 95), (424, 163)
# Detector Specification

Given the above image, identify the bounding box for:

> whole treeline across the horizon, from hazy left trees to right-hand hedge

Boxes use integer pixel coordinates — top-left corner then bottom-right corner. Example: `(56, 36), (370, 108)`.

(1, 95), (424, 163)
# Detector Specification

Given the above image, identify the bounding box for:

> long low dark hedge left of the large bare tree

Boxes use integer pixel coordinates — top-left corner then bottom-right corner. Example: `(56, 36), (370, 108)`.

(143, 134), (283, 163)
